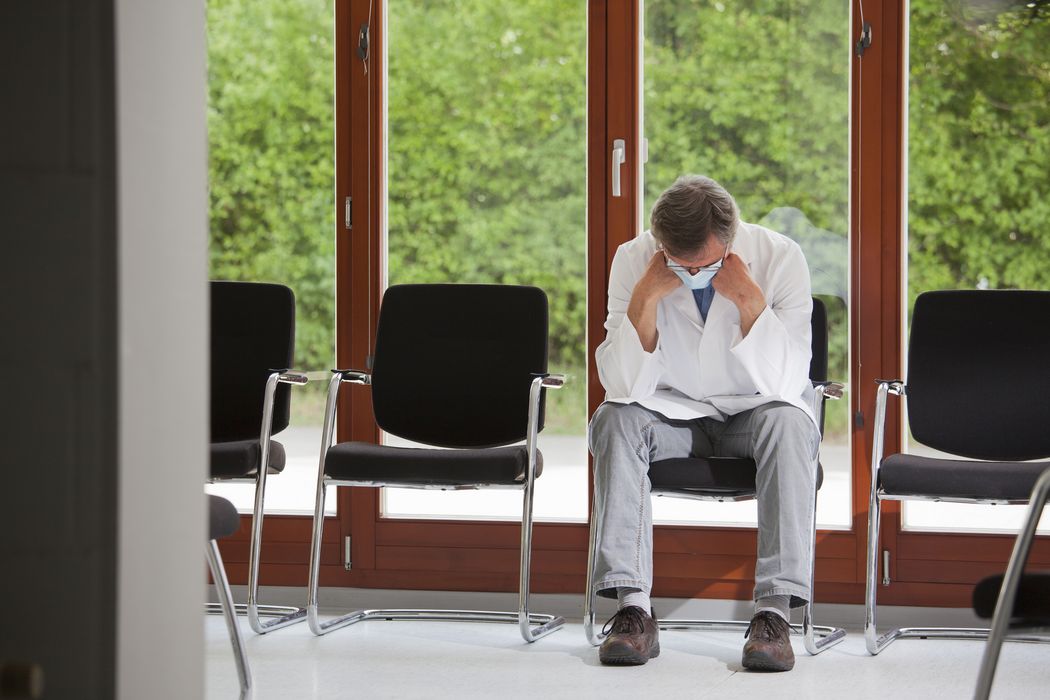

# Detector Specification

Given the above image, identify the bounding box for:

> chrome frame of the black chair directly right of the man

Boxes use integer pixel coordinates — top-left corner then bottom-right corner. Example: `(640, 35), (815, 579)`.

(864, 379), (1050, 655)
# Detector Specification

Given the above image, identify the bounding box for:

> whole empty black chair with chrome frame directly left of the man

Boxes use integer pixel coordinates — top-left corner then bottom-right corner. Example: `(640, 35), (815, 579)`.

(307, 284), (565, 641)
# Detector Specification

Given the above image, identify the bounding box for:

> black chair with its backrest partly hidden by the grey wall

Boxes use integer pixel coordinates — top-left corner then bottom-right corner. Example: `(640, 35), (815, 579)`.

(209, 281), (307, 634)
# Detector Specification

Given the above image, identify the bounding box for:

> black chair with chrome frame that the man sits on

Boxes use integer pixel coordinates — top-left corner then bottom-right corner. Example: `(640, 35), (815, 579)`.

(584, 298), (846, 654)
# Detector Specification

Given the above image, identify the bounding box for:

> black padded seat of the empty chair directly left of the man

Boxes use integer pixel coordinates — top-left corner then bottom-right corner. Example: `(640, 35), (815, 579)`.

(324, 442), (543, 487)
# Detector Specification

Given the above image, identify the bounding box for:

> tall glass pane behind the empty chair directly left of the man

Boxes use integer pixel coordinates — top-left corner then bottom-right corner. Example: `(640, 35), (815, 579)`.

(383, 0), (588, 521)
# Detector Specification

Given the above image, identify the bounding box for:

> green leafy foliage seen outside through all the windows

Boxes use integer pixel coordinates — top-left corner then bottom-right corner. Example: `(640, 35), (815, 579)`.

(208, 0), (1050, 432)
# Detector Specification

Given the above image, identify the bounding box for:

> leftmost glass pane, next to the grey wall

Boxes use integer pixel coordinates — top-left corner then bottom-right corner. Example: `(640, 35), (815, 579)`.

(207, 0), (335, 513)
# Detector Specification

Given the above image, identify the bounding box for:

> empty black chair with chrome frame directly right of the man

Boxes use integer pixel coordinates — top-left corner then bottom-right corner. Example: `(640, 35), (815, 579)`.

(864, 291), (1050, 654)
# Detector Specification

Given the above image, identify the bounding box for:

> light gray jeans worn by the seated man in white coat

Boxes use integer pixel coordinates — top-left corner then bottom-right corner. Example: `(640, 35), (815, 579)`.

(588, 402), (820, 608)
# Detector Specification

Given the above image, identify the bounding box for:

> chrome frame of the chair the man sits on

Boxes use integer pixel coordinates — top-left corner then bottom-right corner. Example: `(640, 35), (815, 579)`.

(584, 382), (846, 656)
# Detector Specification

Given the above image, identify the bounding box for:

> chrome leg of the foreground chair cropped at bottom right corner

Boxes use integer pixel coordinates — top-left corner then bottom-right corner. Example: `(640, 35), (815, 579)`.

(973, 469), (1050, 700)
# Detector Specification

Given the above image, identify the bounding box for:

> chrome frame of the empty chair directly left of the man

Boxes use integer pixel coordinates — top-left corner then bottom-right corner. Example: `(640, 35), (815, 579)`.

(307, 369), (565, 642)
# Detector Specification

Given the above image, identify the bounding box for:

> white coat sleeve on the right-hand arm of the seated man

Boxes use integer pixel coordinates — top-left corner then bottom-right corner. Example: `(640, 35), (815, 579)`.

(731, 245), (813, 398)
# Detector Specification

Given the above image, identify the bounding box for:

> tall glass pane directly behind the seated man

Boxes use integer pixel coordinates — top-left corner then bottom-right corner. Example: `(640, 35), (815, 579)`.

(643, 0), (852, 528)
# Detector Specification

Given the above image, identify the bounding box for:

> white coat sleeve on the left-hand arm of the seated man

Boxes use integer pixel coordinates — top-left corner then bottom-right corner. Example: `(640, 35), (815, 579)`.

(594, 248), (664, 401)
